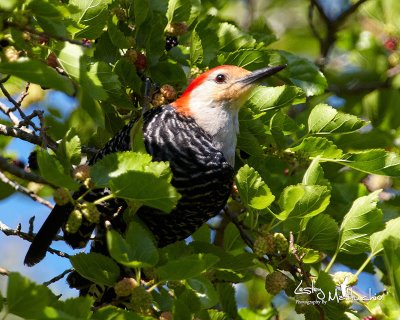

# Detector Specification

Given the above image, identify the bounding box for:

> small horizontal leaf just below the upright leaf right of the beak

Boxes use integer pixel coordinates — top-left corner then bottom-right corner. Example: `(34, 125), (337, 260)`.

(289, 137), (343, 159)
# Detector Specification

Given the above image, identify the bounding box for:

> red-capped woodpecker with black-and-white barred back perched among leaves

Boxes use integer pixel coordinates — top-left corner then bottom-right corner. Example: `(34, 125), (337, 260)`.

(24, 65), (286, 266)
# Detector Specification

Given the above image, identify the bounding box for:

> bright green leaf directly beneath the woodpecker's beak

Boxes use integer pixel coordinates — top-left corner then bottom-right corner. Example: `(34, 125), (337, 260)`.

(247, 86), (303, 113)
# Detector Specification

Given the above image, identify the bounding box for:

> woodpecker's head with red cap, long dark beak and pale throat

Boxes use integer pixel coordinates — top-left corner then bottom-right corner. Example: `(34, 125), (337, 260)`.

(172, 65), (286, 165)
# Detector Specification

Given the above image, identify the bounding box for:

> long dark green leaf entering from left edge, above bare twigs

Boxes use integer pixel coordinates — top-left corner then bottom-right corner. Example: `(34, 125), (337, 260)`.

(0, 60), (75, 95)
